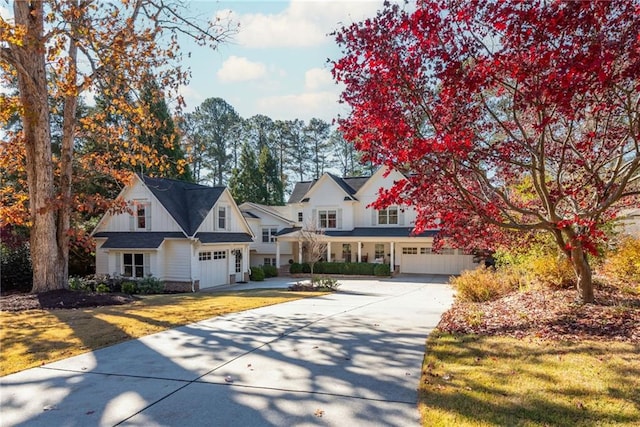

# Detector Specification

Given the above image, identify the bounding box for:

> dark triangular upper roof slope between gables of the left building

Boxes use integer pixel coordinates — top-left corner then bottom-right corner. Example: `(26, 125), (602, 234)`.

(140, 175), (225, 236)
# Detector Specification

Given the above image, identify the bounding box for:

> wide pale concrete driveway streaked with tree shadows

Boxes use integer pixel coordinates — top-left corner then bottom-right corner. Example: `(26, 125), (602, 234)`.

(0, 276), (452, 426)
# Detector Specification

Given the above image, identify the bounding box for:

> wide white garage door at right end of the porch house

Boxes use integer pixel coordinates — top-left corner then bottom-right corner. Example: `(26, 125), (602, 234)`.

(400, 247), (477, 274)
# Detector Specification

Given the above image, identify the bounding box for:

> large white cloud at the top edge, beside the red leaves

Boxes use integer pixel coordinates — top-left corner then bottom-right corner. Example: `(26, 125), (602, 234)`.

(232, 0), (382, 48)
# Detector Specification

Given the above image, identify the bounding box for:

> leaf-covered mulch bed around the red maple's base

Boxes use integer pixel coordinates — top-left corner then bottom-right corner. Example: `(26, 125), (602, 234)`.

(438, 288), (640, 343)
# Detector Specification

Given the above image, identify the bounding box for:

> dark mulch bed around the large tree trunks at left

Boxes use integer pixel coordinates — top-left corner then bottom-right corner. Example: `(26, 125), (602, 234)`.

(0, 289), (136, 311)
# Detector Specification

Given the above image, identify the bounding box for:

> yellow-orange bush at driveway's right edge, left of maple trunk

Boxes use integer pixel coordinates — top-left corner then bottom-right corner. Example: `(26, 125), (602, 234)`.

(450, 266), (513, 302)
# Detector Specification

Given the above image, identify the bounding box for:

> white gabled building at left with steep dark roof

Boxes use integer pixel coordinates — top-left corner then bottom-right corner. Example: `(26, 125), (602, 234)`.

(93, 175), (254, 291)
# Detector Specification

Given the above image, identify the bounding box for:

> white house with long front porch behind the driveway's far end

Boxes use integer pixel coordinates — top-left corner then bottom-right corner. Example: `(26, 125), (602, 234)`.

(240, 169), (477, 274)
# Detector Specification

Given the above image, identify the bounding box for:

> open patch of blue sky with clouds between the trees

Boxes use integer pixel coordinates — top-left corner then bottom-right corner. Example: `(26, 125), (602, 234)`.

(181, 0), (382, 121)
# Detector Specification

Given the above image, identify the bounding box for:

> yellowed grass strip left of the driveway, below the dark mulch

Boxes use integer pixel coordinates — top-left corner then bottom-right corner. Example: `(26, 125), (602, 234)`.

(0, 290), (319, 375)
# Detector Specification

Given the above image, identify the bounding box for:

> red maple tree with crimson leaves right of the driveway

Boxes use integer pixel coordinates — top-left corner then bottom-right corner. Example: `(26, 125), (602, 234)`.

(333, 0), (640, 302)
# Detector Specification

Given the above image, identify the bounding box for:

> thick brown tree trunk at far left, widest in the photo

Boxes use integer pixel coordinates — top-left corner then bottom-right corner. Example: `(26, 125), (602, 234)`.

(12, 1), (66, 292)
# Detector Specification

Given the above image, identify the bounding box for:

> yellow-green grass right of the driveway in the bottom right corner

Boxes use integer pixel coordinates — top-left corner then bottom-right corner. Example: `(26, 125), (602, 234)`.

(419, 332), (640, 427)
